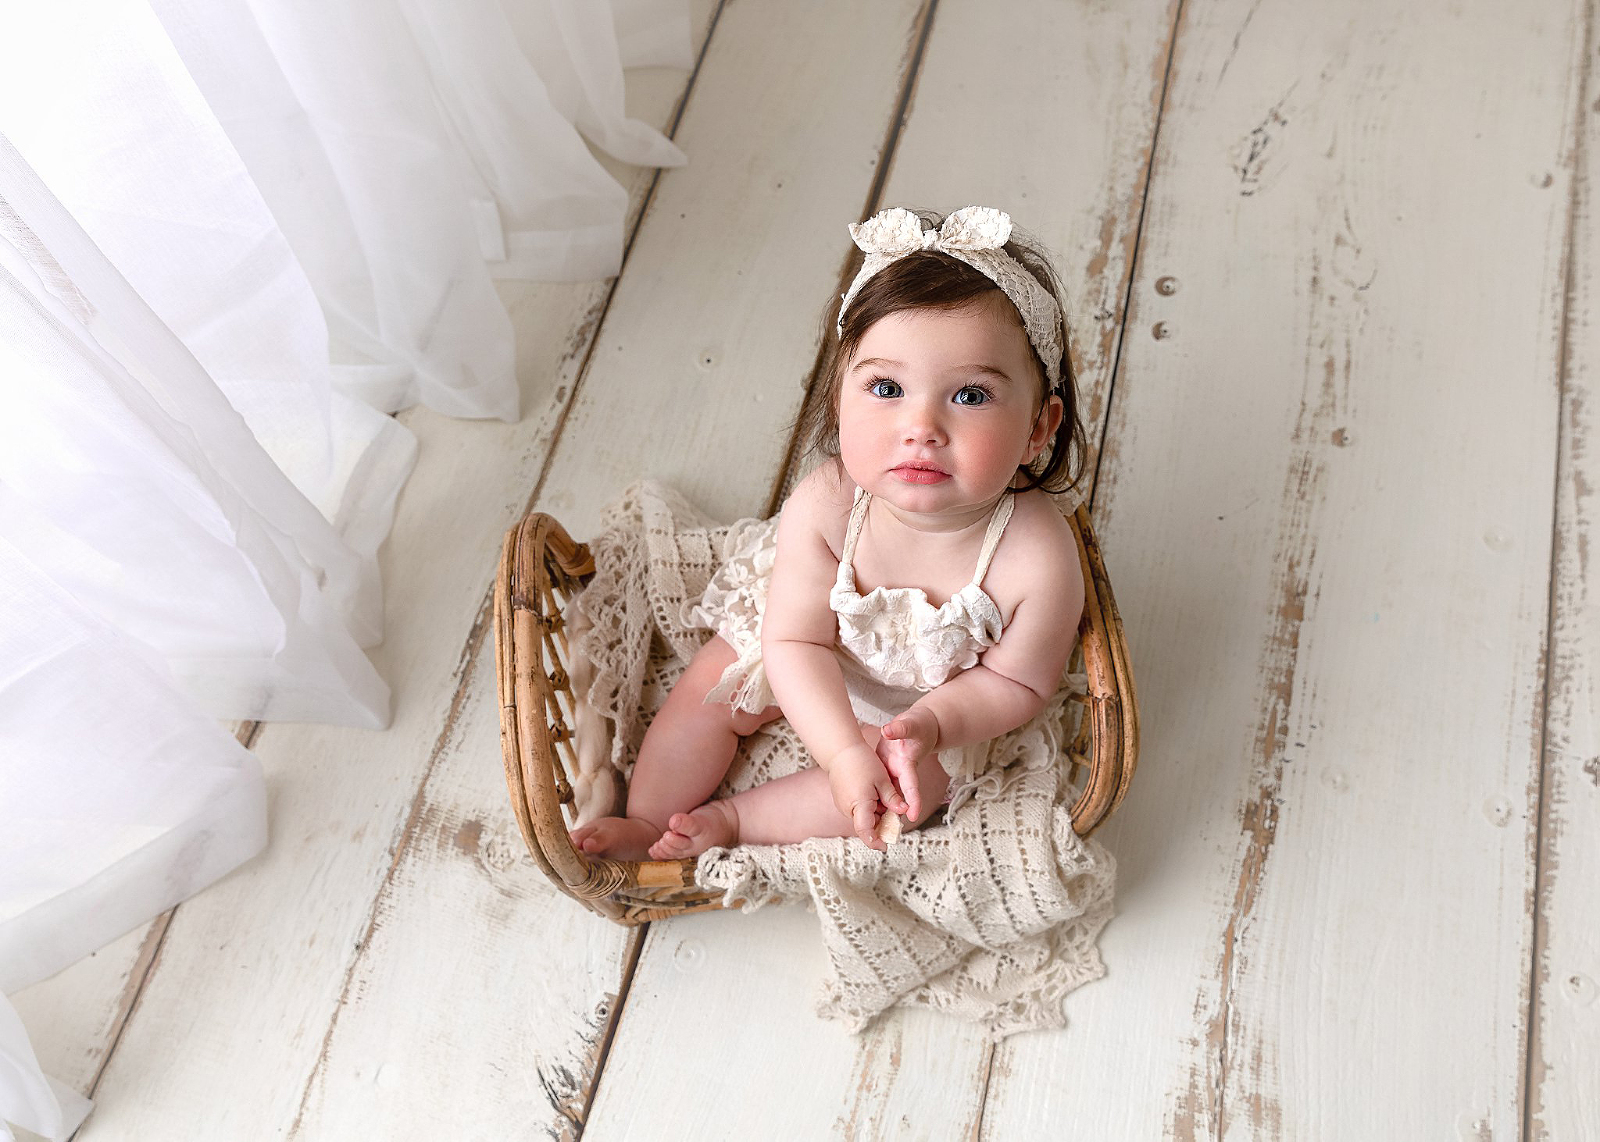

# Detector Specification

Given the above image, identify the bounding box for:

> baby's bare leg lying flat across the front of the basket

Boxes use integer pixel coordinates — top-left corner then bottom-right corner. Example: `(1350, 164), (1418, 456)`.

(650, 726), (950, 859)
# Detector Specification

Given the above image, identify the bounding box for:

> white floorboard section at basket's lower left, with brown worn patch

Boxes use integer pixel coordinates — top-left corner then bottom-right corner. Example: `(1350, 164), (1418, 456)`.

(288, 638), (629, 1142)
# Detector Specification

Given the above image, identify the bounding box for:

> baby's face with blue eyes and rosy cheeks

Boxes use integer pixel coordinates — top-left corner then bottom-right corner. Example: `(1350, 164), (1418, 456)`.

(838, 294), (1061, 517)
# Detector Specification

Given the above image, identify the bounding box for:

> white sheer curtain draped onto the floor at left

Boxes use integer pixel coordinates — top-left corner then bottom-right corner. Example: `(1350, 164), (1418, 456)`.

(0, 0), (691, 1137)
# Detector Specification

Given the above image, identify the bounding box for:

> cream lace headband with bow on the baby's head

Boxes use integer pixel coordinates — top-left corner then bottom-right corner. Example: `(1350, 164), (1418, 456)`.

(838, 206), (1061, 390)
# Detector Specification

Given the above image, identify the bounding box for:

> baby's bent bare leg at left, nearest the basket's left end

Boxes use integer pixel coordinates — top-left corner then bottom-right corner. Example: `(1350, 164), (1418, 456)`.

(571, 635), (778, 860)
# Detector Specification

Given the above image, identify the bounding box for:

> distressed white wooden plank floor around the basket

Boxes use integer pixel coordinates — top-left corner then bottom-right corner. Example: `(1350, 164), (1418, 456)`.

(16, 0), (1600, 1142)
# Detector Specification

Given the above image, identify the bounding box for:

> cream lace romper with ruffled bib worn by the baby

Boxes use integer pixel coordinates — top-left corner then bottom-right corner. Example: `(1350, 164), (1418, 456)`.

(690, 488), (1016, 792)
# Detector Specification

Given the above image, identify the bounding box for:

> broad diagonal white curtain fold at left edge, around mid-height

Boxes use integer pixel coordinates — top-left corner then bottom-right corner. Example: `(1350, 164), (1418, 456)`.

(0, 136), (398, 728)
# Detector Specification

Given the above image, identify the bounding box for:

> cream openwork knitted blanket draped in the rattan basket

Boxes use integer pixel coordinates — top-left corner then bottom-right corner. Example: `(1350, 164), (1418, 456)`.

(571, 483), (1115, 1038)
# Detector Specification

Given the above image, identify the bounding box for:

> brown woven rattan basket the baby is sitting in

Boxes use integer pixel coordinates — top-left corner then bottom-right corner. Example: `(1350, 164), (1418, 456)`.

(494, 507), (1139, 924)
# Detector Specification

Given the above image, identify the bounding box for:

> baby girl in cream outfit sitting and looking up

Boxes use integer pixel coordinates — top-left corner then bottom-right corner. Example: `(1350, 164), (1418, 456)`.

(571, 206), (1083, 860)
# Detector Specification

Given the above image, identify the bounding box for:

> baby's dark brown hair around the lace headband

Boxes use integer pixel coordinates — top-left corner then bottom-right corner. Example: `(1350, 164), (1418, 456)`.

(795, 211), (1088, 493)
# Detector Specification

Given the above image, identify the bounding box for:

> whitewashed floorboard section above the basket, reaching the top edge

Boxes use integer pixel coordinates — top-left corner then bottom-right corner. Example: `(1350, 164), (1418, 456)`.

(539, 0), (918, 536)
